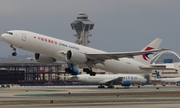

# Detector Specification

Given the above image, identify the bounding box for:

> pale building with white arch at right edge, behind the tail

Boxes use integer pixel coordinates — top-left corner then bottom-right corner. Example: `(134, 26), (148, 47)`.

(150, 51), (180, 78)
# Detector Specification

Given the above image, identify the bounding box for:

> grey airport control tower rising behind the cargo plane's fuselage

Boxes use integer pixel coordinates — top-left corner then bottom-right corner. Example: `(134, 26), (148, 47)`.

(71, 12), (94, 46)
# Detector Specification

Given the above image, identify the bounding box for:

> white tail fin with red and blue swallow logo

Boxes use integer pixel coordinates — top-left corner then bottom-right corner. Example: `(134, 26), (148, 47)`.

(134, 38), (162, 65)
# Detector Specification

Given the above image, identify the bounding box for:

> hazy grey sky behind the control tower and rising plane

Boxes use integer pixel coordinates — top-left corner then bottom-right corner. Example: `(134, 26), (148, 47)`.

(0, 0), (180, 57)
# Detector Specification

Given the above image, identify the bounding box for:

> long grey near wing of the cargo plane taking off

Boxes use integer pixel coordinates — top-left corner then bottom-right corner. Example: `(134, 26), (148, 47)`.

(86, 49), (169, 63)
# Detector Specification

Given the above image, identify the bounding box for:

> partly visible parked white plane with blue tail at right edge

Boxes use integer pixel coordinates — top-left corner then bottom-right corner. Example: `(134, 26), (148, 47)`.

(156, 72), (180, 85)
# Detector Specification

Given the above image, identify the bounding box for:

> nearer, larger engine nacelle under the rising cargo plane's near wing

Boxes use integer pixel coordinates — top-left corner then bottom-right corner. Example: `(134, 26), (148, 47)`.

(65, 50), (87, 64)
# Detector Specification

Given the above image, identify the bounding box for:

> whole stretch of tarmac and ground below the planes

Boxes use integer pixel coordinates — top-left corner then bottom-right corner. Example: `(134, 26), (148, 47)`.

(0, 85), (180, 108)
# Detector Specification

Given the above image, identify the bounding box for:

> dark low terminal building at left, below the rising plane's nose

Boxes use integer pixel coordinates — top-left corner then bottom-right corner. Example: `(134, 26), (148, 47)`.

(0, 60), (68, 85)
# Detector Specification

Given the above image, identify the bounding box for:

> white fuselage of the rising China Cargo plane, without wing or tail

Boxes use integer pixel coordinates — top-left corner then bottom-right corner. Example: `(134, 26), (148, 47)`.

(2, 30), (151, 73)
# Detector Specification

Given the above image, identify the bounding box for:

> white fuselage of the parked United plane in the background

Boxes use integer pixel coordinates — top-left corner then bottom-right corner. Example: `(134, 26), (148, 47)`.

(67, 74), (147, 85)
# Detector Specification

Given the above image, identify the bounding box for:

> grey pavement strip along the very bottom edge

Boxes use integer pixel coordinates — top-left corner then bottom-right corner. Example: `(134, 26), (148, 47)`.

(1, 102), (180, 108)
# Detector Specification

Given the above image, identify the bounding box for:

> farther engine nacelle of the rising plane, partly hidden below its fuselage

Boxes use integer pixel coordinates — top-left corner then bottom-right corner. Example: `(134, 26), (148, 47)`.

(34, 53), (56, 64)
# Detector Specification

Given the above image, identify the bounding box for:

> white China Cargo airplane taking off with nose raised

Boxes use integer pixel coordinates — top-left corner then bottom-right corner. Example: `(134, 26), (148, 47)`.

(1, 30), (167, 76)
